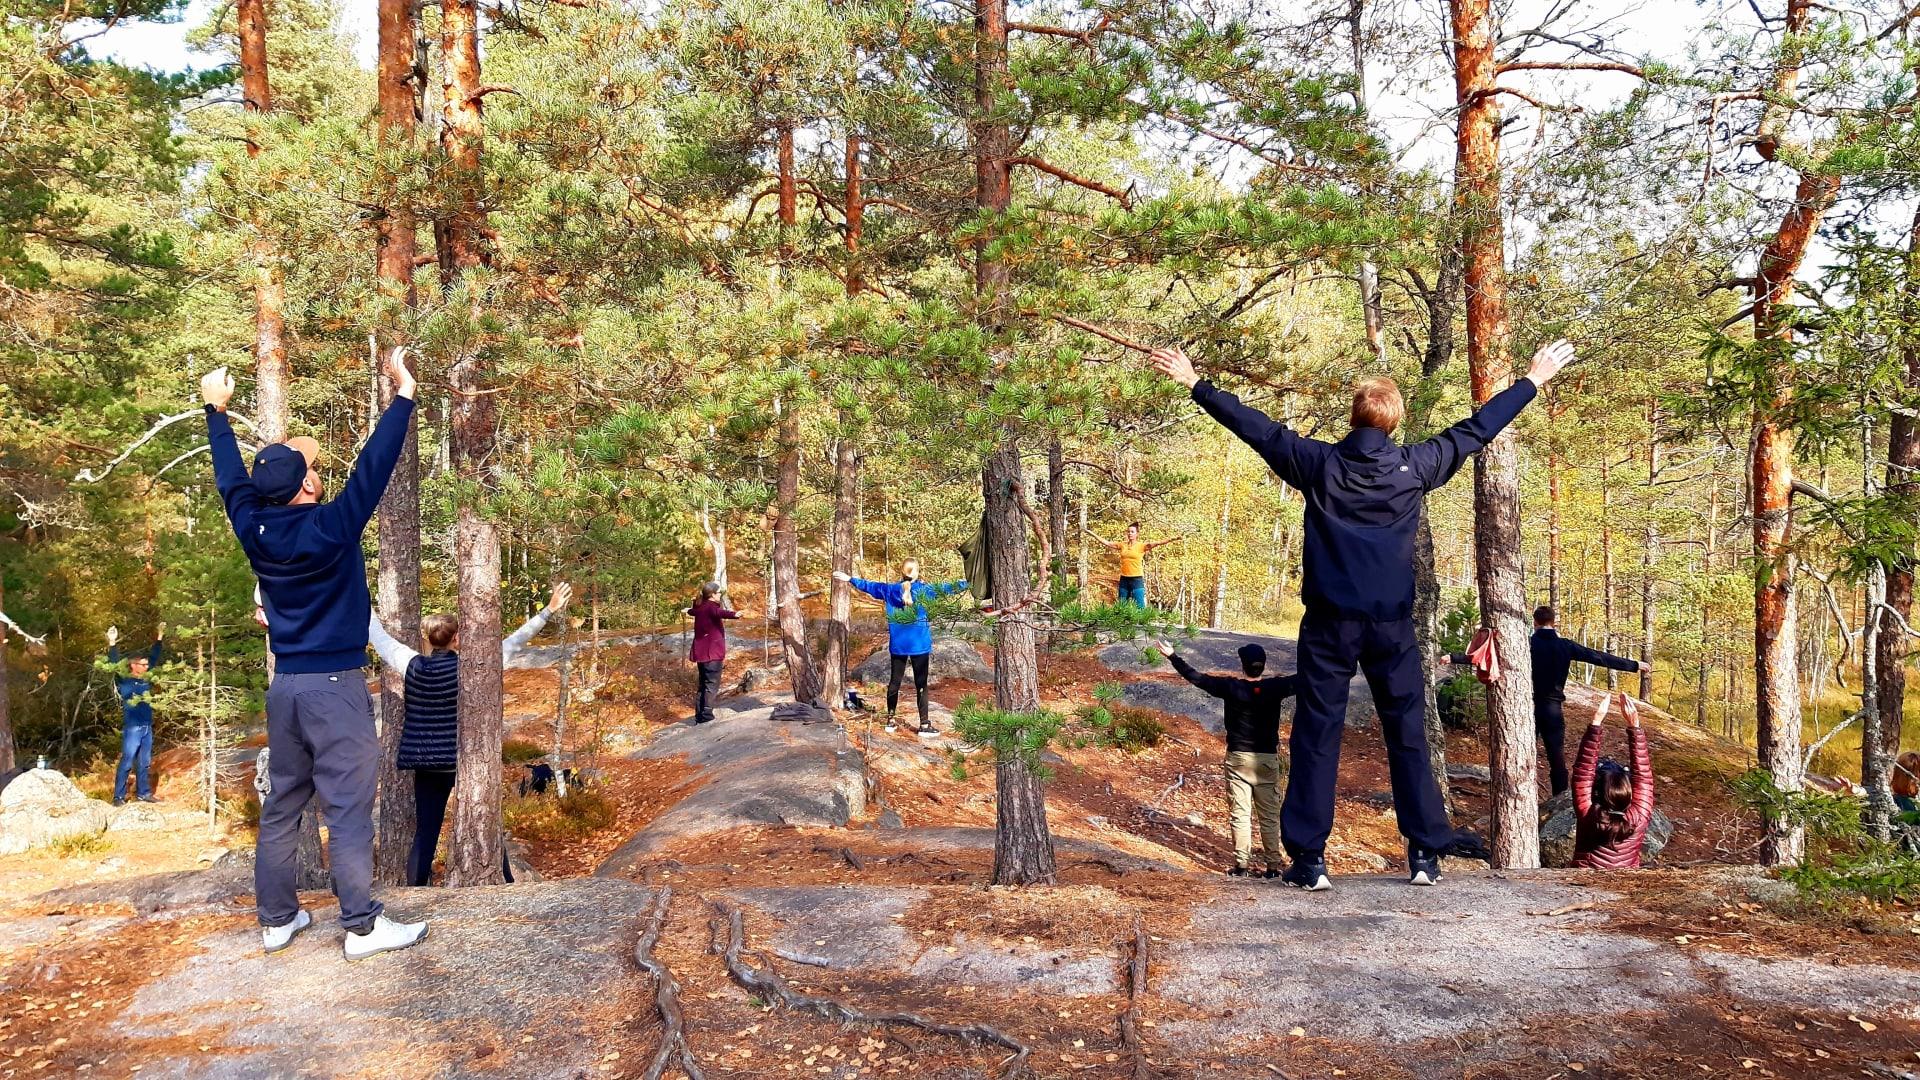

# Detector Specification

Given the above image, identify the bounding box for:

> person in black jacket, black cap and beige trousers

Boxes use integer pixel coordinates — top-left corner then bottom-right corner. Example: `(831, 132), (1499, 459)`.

(1160, 642), (1300, 878)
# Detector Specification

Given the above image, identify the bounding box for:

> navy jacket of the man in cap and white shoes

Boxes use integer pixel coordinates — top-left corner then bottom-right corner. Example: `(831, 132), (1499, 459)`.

(207, 398), (413, 675)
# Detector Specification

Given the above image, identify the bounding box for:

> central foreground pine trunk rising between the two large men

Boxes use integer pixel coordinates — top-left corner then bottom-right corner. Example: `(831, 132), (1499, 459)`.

(968, 0), (1054, 884)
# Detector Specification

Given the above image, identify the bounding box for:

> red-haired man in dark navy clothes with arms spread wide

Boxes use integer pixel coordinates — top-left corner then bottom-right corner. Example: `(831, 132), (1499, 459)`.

(1154, 342), (1572, 890)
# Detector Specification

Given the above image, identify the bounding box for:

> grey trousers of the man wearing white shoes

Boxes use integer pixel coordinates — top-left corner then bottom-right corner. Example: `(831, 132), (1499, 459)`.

(253, 669), (380, 934)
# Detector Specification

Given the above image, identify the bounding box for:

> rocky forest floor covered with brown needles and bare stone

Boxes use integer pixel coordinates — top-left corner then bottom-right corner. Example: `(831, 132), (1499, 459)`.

(0, 618), (1920, 1080)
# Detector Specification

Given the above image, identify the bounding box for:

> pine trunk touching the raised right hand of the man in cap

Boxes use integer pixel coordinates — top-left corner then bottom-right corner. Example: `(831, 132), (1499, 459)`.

(372, 0), (420, 884)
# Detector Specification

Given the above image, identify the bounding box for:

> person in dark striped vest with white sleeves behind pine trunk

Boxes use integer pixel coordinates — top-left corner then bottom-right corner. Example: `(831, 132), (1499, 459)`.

(367, 582), (574, 886)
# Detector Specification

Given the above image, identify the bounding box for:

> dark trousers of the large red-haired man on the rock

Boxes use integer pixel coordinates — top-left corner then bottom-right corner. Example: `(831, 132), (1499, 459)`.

(1281, 611), (1453, 857)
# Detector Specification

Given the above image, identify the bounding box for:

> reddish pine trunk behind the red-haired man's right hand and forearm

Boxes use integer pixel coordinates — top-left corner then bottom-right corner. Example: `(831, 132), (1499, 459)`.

(1450, 0), (1540, 867)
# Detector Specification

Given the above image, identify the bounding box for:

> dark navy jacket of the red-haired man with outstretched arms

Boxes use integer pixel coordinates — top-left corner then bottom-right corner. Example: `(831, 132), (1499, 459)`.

(1192, 379), (1538, 621)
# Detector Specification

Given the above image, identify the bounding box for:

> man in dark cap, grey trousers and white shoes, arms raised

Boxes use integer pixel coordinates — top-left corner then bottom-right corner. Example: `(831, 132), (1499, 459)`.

(200, 350), (426, 959)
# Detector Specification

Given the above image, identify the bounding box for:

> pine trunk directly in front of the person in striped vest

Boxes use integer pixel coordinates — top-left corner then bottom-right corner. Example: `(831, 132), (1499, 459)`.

(438, 0), (505, 886)
